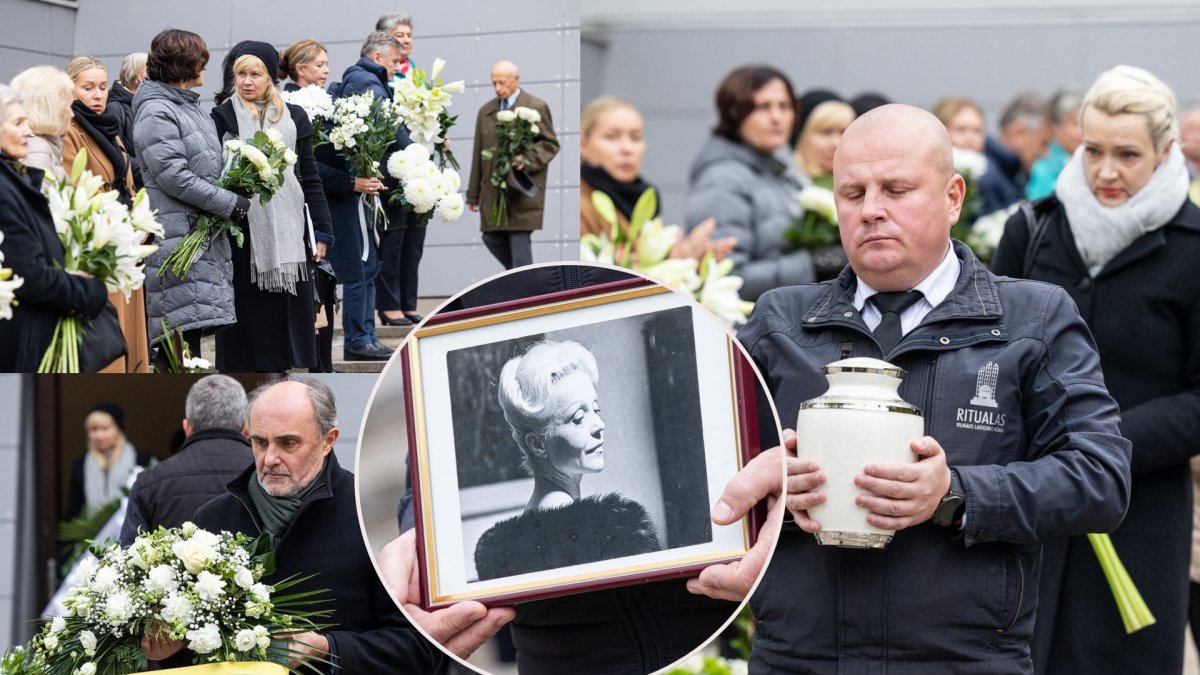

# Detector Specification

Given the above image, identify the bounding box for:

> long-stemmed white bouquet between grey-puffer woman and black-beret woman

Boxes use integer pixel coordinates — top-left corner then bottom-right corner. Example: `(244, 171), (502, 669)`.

(158, 129), (296, 279)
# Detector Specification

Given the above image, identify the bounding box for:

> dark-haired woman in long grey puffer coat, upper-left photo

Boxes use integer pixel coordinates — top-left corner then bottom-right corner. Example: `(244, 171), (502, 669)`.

(133, 30), (250, 363)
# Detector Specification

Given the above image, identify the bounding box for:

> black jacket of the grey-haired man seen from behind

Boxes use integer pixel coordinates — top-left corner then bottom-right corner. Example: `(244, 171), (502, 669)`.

(121, 429), (254, 546)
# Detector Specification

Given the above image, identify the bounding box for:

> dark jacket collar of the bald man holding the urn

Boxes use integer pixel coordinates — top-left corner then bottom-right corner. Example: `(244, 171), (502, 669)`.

(803, 240), (1003, 329)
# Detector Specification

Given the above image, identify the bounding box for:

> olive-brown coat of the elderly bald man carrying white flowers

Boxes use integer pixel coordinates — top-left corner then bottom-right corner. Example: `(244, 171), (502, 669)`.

(467, 89), (558, 232)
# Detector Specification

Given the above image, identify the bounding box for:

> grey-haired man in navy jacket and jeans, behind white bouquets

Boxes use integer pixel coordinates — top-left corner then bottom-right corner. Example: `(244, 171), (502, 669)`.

(326, 30), (410, 360)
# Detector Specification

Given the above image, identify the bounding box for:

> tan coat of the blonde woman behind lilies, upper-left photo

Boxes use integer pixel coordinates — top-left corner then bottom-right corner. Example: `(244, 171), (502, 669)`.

(62, 120), (150, 372)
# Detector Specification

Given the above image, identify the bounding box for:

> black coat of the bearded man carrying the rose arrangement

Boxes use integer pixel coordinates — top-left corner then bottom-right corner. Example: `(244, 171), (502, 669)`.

(194, 453), (443, 675)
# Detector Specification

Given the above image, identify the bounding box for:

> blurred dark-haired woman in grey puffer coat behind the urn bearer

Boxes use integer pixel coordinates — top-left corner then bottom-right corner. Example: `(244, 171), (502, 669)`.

(685, 66), (825, 300)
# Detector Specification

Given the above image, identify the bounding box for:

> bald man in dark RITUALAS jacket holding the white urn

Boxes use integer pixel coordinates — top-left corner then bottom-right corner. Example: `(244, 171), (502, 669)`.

(691, 104), (1130, 675)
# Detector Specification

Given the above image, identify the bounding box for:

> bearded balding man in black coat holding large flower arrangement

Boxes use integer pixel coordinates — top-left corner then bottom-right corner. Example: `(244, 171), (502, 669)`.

(194, 378), (443, 675)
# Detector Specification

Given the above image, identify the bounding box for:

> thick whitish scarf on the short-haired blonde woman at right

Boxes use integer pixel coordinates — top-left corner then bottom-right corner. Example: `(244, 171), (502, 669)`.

(1055, 142), (1188, 276)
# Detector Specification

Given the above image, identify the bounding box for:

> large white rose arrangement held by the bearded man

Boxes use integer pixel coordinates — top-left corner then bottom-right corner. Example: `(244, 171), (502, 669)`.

(0, 522), (329, 675)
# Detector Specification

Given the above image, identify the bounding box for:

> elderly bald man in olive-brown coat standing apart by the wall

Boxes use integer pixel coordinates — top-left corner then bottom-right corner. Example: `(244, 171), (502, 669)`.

(467, 61), (558, 269)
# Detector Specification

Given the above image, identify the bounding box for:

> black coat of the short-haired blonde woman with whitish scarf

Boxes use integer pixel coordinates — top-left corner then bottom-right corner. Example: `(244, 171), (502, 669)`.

(992, 196), (1200, 675)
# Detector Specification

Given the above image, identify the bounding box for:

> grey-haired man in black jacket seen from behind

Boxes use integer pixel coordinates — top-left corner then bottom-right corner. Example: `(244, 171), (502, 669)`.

(121, 375), (254, 546)
